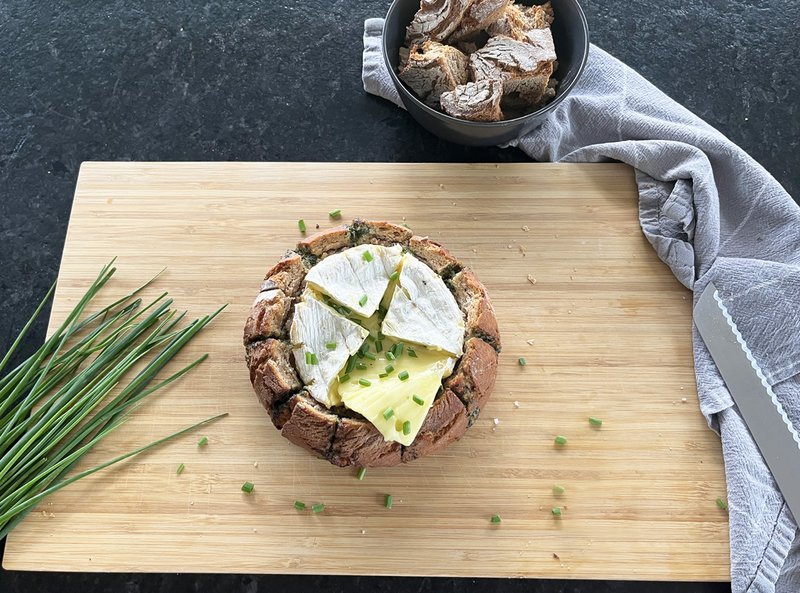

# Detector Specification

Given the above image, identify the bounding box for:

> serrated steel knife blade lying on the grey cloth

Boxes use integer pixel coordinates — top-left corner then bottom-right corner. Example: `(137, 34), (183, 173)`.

(694, 282), (800, 518)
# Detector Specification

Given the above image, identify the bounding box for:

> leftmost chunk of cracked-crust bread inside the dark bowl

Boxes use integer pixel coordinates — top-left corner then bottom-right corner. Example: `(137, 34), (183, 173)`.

(398, 41), (469, 107)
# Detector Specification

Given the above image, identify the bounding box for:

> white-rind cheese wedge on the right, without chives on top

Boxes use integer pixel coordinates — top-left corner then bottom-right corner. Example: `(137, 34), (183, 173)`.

(381, 253), (464, 356)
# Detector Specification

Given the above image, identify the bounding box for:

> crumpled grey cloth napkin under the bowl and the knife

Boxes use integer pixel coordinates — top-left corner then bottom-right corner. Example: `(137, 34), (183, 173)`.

(363, 19), (800, 593)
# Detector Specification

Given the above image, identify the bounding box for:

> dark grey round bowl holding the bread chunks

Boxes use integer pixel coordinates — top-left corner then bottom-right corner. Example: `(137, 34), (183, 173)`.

(383, 0), (589, 146)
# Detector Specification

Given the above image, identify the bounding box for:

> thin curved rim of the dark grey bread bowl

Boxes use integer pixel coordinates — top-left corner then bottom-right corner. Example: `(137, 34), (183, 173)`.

(381, 0), (590, 129)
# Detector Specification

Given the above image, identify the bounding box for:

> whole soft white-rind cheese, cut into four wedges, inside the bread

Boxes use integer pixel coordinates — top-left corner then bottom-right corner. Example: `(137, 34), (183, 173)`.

(289, 245), (464, 445)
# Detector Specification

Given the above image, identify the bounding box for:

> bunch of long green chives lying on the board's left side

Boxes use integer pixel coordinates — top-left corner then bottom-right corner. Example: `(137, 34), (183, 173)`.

(0, 261), (225, 539)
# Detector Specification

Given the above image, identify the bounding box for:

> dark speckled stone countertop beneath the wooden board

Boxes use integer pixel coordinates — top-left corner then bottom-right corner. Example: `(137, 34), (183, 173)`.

(0, 0), (800, 593)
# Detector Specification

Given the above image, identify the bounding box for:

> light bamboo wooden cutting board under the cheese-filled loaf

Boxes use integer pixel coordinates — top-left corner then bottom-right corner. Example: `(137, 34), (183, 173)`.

(4, 163), (729, 580)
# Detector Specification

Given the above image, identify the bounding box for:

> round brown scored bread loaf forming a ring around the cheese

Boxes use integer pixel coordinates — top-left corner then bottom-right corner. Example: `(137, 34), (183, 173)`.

(244, 219), (500, 467)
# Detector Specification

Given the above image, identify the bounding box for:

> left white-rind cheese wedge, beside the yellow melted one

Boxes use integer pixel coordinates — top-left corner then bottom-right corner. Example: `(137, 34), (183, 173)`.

(289, 290), (369, 406)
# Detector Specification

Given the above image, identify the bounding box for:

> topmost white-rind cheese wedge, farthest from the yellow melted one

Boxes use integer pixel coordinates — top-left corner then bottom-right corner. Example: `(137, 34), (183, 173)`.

(306, 245), (403, 317)
